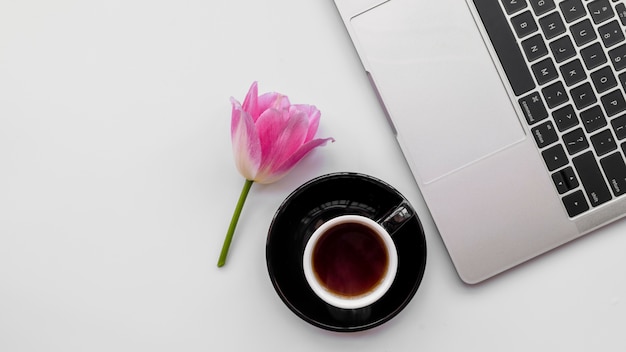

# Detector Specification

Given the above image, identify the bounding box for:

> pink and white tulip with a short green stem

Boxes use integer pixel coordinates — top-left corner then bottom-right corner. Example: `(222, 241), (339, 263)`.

(217, 82), (334, 266)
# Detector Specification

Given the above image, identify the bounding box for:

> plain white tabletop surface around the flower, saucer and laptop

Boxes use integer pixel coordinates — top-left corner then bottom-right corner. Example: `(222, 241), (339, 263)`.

(0, 0), (626, 352)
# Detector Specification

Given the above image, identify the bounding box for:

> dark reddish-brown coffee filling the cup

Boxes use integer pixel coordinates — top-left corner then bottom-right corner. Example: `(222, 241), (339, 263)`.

(312, 223), (389, 297)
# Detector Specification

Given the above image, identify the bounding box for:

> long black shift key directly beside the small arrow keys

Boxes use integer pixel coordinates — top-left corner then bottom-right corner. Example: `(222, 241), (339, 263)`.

(573, 151), (611, 207)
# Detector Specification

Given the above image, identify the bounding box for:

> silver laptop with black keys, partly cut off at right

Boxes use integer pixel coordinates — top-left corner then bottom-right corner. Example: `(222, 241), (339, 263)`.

(334, 0), (626, 284)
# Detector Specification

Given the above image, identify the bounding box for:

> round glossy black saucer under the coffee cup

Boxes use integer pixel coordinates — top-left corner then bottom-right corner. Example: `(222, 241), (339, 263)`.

(266, 173), (426, 332)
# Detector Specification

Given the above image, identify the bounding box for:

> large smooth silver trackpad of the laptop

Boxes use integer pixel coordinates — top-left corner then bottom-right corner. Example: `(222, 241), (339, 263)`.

(352, 0), (526, 183)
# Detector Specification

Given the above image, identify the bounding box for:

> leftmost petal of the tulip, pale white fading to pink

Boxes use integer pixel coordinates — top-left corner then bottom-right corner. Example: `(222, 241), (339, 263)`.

(231, 99), (262, 180)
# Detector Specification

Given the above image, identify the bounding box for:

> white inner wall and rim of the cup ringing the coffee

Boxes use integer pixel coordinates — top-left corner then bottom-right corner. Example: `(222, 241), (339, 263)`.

(302, 215), (398, 309)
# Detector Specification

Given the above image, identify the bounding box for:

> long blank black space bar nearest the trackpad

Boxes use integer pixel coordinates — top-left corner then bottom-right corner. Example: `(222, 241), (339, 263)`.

(474, 0), (535, 96)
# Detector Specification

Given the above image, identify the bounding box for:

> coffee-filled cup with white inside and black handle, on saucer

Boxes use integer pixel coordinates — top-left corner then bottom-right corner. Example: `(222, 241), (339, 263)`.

(302, 205), (413, 309)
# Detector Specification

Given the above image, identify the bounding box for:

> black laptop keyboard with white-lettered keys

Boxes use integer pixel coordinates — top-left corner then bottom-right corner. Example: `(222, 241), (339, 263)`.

(474, 0), (626, 217)
